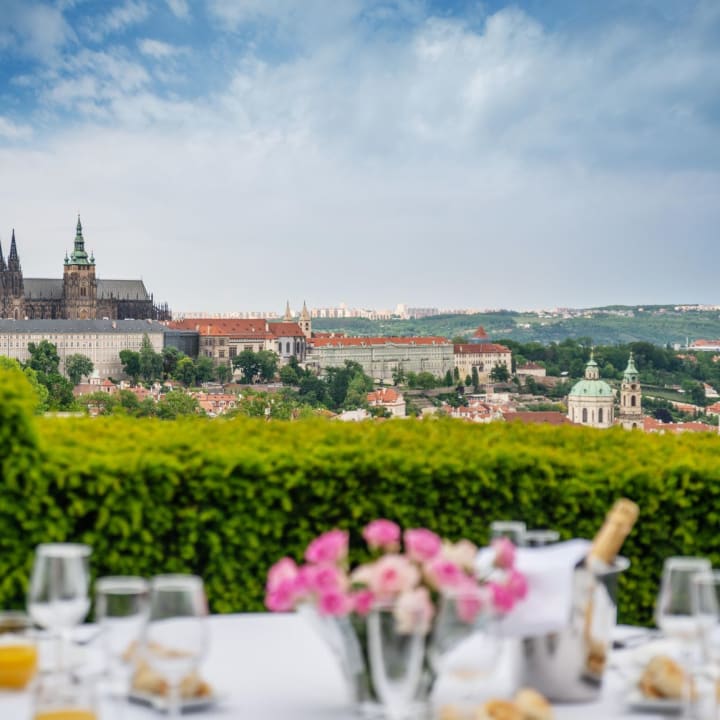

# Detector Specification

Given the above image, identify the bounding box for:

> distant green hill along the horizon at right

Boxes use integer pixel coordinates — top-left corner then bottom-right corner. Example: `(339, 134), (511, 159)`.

(313, 305), (720, 345)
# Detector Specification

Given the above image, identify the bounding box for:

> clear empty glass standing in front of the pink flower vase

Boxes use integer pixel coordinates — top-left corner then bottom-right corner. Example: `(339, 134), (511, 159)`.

(367, 606), (427, 720)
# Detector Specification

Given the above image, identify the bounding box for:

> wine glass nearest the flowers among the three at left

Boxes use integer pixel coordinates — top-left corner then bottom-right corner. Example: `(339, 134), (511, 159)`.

(142, 575), (208, 718)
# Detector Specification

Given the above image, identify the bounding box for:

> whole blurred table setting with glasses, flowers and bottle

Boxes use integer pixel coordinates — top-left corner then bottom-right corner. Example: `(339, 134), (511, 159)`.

(0, 500), (720, 720)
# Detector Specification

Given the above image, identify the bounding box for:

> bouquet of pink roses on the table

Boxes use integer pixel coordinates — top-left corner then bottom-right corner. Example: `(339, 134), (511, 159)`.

(265, 520), (527, 633)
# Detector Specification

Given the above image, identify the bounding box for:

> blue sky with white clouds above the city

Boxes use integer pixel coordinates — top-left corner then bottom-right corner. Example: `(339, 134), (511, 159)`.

(0, 0), (720, 312)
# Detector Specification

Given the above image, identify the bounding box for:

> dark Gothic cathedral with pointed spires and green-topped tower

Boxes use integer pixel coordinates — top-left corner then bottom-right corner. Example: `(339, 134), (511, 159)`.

(0, 216), (170, 320)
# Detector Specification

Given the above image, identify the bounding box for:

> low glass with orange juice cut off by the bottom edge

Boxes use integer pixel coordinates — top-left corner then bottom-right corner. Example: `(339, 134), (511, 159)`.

(32, 674), (98, 720)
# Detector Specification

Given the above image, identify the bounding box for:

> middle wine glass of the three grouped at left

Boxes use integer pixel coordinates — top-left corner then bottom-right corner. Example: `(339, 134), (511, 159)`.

(95, 576), (150, 707)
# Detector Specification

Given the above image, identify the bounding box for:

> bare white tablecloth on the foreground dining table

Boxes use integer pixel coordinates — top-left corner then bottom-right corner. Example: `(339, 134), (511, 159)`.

(0, 614), (661, 720)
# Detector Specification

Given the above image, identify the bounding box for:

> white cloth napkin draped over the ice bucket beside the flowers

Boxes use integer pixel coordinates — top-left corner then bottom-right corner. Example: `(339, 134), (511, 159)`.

(477, 539), (591, 637)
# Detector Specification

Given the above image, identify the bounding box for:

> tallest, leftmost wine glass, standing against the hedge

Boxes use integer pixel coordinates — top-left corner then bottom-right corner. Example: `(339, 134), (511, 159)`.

(28, 543), (92, 671)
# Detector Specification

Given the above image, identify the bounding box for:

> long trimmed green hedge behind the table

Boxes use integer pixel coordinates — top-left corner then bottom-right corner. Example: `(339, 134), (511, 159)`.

(0, 371), (720, 623)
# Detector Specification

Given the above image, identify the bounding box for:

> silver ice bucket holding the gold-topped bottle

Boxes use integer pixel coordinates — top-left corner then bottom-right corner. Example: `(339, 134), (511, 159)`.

(520, 557), (630, 702)
